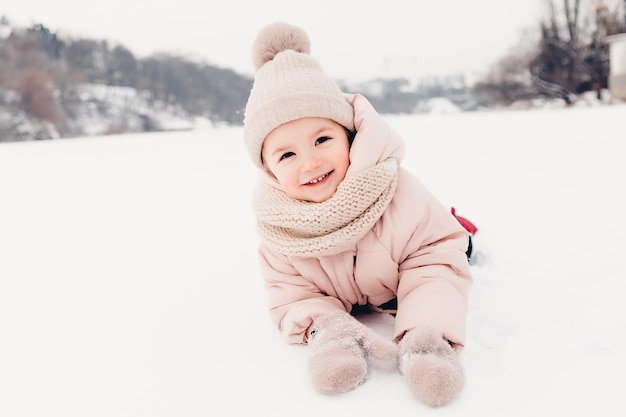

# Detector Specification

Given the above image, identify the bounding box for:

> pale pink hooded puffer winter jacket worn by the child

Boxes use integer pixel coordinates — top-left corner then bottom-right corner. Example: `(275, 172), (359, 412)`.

(254, 94), (472, 348)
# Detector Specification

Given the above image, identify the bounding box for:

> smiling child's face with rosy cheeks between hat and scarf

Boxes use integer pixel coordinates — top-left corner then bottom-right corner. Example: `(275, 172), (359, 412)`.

(261, 117), (350, 203)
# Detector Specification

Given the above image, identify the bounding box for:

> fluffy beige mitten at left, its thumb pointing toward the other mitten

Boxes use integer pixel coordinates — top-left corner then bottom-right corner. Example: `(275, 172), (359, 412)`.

(309, 311), (398, 394)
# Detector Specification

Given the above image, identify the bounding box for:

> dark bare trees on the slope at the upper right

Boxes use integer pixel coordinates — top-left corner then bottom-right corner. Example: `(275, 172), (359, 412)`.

(473, 0), (626, 103)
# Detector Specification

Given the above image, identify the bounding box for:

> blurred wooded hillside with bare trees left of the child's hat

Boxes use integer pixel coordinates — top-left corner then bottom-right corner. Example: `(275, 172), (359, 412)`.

(0, 17), (252, 141)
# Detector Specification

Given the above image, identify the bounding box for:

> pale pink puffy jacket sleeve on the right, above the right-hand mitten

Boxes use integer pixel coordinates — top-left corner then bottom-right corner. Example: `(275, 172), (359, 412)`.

(394, 171), (472, 348)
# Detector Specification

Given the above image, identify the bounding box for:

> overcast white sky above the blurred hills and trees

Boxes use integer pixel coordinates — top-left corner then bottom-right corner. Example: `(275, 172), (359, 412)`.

(0, 0), (542, 81)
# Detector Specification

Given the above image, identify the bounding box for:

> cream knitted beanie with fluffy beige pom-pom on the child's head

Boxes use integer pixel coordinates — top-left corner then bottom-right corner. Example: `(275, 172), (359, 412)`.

(244, 22), (354, 167)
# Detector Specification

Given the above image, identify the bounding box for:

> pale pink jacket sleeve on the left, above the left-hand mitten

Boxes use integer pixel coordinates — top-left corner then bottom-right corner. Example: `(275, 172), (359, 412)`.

(259, 244), (350, 344)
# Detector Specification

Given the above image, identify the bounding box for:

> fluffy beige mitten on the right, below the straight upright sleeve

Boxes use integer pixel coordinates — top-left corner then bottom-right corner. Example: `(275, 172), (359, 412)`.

(398, 326), (465, 407)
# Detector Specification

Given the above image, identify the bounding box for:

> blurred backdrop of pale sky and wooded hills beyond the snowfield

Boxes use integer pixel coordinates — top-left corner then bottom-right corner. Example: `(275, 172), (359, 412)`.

(0, 0), (626, 142)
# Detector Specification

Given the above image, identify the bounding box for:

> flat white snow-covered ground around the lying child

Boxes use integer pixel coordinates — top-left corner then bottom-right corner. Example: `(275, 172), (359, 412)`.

(0, 105), (626, 417)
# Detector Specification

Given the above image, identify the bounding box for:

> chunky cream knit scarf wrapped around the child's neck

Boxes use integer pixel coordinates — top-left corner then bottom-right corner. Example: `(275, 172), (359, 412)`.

(253, 158), (398, 256)
